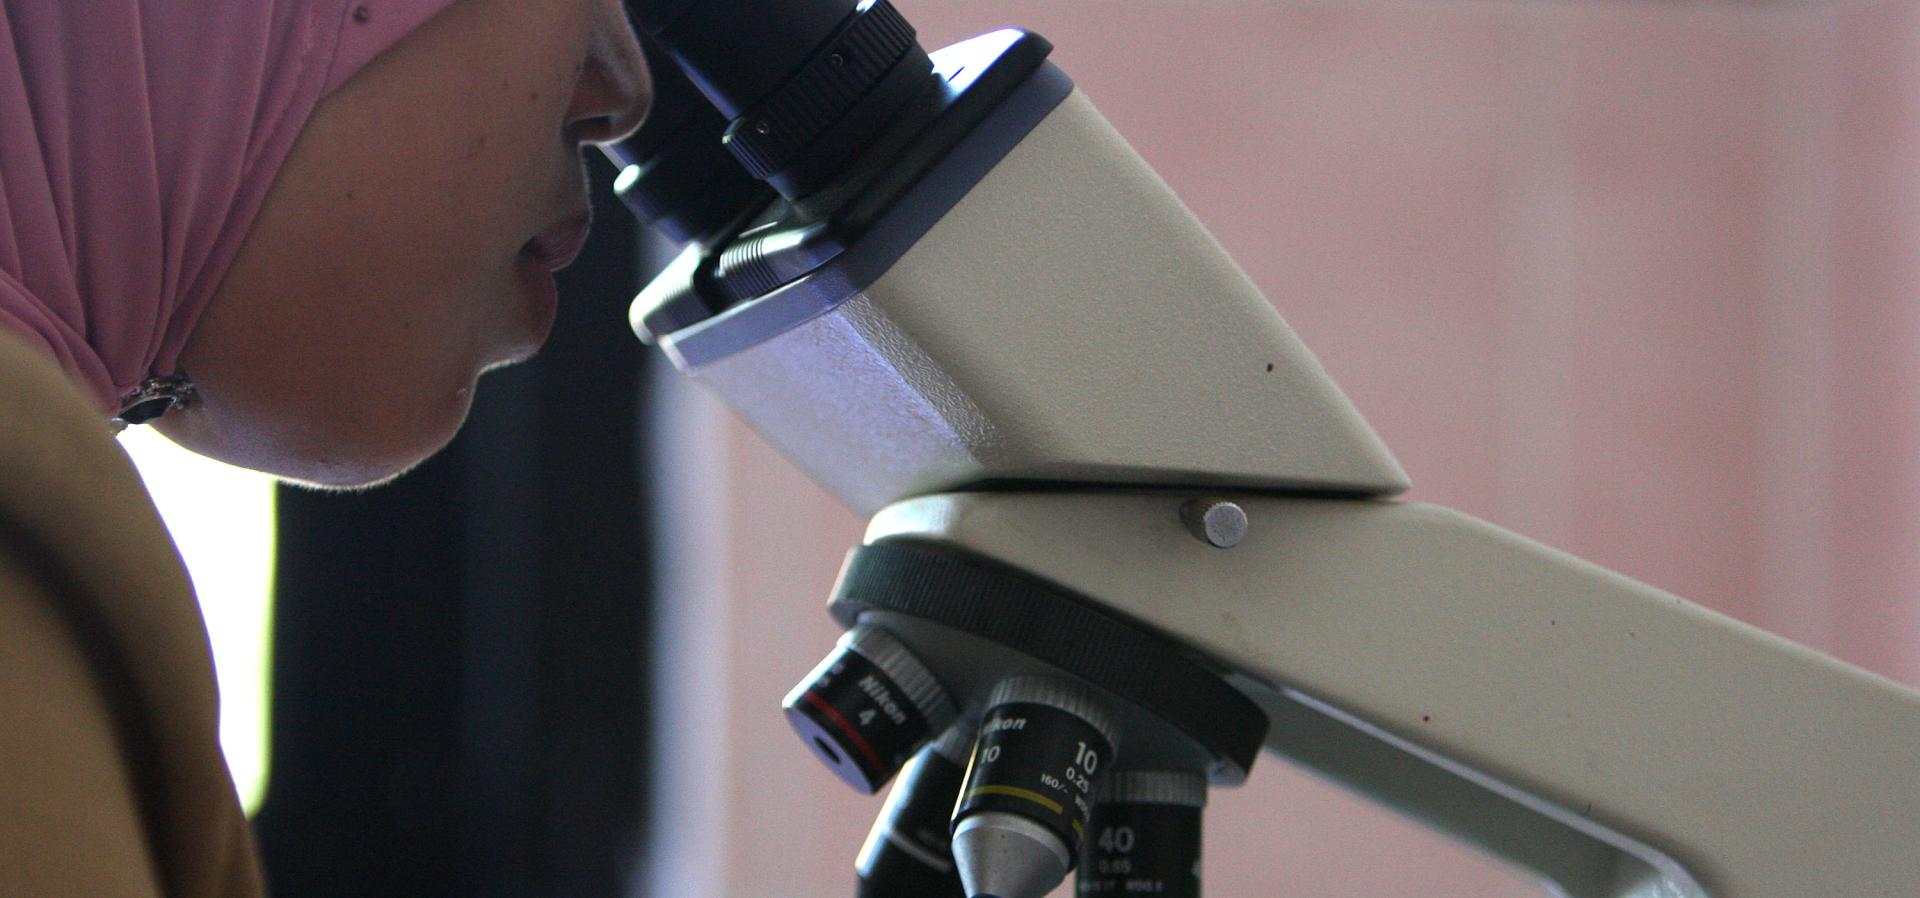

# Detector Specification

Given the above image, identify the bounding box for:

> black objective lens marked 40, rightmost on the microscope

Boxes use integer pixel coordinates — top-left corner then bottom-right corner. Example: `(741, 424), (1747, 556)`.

(1077, 769), (1206, 898)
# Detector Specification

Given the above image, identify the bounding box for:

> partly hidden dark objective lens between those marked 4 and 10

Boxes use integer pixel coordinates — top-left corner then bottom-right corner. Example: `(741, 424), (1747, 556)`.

(854, 723), (973, 898)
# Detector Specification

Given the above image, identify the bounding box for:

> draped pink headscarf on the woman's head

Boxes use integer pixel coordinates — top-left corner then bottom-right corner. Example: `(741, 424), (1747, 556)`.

(0, 0), (451, 413)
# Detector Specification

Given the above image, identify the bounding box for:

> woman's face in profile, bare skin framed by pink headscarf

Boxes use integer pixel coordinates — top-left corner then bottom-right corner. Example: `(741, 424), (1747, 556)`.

(159, 0), (651, 485)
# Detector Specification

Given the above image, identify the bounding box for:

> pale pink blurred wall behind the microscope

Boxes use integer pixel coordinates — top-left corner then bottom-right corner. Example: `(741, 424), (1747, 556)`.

(645, 0), (1920, 898)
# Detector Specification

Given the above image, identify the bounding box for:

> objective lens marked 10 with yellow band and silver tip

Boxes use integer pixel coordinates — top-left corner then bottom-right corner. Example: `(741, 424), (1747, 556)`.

(954, 677), (1114, 898)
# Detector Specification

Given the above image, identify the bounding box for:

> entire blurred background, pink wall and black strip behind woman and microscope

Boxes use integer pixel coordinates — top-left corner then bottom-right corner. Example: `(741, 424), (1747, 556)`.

(123, 0), (1920, 898)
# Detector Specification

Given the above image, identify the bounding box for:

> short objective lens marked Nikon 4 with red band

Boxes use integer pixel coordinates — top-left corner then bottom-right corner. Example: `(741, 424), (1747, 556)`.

(785, 624), (958, 794)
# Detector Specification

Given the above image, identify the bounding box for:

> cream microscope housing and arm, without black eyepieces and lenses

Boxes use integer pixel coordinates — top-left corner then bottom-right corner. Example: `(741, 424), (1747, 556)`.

(636, 21), (1920, 898)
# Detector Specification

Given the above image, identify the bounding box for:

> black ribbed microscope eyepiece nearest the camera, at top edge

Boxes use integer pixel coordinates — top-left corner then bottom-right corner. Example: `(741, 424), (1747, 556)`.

(634, 0), (933, 200)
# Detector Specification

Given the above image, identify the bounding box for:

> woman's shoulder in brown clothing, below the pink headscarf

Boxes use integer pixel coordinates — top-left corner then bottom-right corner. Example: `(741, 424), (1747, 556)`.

(0, 328), (257, 898)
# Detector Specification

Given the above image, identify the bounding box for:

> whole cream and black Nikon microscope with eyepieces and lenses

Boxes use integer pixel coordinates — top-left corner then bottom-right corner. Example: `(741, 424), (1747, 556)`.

(611, 0), (1920, 898)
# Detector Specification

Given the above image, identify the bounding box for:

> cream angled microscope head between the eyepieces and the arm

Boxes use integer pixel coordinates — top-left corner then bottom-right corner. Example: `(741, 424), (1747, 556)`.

(632, 17), (1405, 512)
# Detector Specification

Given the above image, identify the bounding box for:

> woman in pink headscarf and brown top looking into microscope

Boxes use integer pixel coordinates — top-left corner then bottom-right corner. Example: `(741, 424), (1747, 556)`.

(0, 0), (649, 898)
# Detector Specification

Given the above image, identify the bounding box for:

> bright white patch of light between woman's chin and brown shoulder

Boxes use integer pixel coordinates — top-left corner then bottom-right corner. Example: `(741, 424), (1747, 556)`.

(121, 428), (275, 814)
